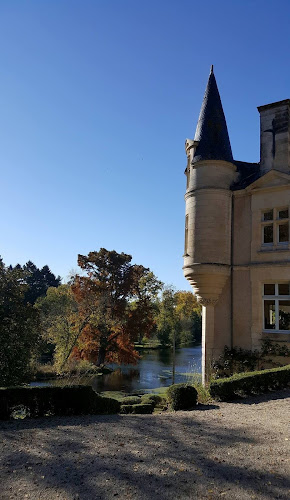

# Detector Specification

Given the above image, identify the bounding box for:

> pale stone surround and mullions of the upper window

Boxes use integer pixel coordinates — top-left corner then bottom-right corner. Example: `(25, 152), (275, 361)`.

(261, 205), (290, 250)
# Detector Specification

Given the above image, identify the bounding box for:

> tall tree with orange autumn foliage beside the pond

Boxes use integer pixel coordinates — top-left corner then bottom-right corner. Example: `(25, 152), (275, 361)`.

(71, 248), (162, 366)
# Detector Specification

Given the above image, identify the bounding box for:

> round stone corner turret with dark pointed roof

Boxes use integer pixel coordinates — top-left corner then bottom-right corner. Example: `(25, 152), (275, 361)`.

(183, 67), (237, 376)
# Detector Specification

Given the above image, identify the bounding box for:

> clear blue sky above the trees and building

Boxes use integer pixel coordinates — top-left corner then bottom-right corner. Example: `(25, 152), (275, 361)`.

(0, 0), (290, 289)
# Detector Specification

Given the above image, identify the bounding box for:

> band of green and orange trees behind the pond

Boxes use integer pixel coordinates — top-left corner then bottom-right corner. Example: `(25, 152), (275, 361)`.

(0, 248), (201, 386)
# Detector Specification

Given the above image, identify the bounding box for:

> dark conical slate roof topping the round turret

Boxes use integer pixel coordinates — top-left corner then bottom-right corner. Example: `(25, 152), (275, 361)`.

(193, 66), (233, 163)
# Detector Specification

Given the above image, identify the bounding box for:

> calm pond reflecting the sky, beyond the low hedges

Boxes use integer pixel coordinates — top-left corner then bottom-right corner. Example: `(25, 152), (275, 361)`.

(31, 346), (201, 394)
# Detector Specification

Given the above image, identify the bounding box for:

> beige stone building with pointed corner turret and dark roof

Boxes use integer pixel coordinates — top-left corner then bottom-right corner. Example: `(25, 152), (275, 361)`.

(183, 68), (290, 380)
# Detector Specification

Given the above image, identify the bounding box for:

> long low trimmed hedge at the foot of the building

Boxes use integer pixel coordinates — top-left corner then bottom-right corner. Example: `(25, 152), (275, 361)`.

(209, 365), (290, 401)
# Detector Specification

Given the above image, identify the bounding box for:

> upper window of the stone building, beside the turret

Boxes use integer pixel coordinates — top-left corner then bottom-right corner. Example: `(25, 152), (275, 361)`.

(262, 207), (289, 248)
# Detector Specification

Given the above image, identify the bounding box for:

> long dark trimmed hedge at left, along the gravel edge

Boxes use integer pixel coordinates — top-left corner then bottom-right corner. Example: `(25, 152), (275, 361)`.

(0, 385), (120, 420)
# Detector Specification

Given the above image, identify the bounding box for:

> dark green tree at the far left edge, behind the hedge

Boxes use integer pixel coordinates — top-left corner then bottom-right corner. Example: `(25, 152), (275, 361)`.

(0, 259), (38, 386)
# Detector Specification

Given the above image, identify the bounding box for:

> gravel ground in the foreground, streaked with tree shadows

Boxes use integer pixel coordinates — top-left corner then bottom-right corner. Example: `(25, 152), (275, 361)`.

(0, 390), (290, 500)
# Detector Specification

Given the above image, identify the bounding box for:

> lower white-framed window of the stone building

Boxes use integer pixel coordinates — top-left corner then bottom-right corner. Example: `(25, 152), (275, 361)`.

(263, 282), (290, 333)
